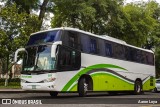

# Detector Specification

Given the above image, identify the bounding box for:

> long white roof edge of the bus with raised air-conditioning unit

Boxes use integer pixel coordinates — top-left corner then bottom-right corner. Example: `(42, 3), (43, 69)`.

(31, 27), (154, 53)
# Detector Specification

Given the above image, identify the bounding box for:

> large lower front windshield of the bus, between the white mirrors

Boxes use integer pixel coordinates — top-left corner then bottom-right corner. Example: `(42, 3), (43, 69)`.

(23, 45), (55, 71)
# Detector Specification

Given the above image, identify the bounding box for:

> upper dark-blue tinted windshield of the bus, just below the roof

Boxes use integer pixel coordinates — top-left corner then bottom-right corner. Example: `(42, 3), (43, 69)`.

(27, 30), (60, 46)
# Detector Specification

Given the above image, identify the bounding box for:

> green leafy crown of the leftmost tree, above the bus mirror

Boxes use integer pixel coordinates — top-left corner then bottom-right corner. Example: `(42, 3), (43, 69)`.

(0, 4), (39, 54)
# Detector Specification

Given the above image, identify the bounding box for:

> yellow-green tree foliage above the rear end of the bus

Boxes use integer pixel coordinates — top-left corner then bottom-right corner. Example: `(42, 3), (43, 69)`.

(120, 4), (157, 47)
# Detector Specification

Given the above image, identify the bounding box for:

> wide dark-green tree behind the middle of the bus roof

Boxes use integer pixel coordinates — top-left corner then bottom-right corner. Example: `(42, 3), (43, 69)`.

(51, 0), (122, 34)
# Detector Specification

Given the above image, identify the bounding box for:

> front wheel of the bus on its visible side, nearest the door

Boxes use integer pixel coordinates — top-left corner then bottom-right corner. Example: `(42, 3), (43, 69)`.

(78, 77), (88, 97)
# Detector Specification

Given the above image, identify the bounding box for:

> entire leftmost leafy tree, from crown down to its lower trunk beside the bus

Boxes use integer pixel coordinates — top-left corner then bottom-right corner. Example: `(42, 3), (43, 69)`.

(0, 4), (40, 80)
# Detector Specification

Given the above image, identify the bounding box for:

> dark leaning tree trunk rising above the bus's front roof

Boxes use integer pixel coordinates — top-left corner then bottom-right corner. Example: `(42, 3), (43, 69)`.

(38, 0), (49, 30)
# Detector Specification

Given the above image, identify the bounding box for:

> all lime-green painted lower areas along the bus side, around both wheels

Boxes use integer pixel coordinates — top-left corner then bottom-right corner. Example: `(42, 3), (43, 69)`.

(68, 71), (154, 91)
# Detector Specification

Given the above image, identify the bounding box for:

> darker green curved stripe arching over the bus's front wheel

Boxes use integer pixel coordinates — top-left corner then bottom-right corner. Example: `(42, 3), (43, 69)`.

(62, 64), (127, 91)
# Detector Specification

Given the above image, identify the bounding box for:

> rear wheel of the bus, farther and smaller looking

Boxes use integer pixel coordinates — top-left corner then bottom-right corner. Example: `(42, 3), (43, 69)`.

(134, 80), (142, 95)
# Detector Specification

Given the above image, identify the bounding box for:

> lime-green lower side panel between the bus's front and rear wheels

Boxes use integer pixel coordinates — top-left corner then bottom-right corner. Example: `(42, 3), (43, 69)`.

(92, 72), (134, 91)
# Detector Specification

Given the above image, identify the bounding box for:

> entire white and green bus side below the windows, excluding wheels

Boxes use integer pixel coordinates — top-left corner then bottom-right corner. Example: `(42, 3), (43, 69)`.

(56, 53), (155, 91)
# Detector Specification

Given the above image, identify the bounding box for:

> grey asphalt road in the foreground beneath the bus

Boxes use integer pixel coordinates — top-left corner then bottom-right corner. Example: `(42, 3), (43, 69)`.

(0, 92), (160, 107)
